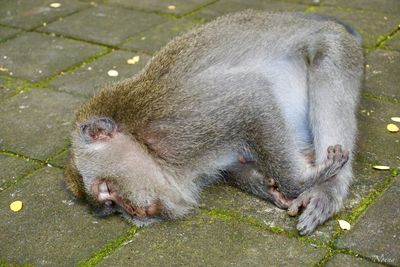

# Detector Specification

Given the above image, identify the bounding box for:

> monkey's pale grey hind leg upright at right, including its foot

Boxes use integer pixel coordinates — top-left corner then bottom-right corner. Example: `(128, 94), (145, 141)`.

(288, 32), (363, 234)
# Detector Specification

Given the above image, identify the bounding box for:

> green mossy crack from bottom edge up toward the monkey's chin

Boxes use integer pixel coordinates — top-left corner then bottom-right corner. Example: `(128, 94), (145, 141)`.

(78, 226), (143, 267)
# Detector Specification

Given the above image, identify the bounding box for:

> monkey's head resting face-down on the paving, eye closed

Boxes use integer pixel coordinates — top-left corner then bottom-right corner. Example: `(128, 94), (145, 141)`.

(66, 117), (173, 225)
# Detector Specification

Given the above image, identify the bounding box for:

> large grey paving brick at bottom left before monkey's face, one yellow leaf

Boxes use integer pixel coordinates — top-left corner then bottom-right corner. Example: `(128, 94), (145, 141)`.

(0, 168), (130, 266)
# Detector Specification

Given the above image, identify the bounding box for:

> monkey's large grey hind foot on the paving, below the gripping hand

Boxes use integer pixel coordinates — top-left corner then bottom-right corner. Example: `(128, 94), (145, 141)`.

(288, 177), (345, 235)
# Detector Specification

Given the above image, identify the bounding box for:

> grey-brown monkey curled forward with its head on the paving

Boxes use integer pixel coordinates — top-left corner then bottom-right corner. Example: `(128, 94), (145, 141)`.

(66, 10), (363, 235)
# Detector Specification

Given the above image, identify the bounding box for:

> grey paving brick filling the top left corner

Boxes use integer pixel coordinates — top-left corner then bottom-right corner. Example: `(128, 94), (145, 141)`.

(0, 0), (88, 29)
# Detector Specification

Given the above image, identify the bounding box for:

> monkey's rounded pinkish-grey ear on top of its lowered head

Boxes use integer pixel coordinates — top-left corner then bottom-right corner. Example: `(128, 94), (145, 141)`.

(79, 117), (117, 143)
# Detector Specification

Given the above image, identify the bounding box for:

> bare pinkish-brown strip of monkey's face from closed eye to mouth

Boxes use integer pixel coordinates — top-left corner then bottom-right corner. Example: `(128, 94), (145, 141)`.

(92, 180), (161, 219)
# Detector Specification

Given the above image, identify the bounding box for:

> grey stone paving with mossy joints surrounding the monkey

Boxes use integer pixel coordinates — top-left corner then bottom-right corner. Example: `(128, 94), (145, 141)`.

(0, 0), (400, 266)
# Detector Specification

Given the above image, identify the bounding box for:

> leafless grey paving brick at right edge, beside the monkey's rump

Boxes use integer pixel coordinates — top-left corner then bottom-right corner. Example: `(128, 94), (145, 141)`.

(365, 49), (400, 100)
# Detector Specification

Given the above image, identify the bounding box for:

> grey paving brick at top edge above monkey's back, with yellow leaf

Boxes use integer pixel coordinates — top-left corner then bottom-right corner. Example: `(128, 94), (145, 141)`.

(108, 0), (213, 15)
